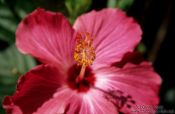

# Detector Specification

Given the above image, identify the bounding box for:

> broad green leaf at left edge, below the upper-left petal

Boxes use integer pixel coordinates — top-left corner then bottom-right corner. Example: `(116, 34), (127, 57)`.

(0, 45), (36, 84)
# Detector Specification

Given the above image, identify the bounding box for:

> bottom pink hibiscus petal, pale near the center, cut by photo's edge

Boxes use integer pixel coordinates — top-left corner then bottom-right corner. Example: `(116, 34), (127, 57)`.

(34, 88), (117, 114)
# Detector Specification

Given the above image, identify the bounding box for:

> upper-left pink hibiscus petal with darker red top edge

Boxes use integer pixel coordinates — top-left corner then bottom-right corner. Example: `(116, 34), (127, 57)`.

(16, 9), (74, 67)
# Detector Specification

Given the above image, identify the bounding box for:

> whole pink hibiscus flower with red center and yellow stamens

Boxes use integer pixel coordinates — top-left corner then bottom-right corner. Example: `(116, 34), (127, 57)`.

(3, 9), (161, 114)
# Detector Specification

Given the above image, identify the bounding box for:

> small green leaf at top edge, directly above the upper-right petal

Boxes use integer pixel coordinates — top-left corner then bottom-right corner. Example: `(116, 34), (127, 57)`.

(107, 0), (134, 11)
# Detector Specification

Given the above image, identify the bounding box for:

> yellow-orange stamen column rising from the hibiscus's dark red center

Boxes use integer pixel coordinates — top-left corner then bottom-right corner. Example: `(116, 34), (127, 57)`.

(74, 33), (96, 80)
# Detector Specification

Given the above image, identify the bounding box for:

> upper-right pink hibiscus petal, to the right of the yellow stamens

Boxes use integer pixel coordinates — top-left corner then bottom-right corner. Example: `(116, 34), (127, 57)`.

(74, 8), (142, 64)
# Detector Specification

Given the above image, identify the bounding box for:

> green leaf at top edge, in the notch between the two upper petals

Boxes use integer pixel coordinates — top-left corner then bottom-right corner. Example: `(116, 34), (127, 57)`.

(65, 0), (92, 23)
